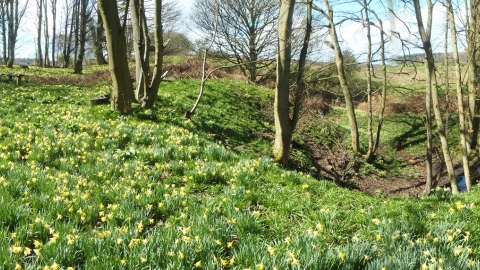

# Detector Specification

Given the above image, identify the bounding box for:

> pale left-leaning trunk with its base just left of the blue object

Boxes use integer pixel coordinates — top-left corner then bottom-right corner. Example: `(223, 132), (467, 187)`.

(413, 0), (458, 194)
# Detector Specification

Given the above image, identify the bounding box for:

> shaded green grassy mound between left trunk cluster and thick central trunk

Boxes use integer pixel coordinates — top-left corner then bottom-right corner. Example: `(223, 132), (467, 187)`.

(144, 80), (273, 156)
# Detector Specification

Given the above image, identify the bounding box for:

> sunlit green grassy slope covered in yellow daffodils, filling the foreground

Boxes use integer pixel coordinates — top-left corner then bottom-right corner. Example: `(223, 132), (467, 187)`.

(0, 66), (480, 269)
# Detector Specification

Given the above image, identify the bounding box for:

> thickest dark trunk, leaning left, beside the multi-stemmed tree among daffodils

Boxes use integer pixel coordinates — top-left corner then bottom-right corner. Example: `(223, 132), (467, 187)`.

(98, 0), (135, 114)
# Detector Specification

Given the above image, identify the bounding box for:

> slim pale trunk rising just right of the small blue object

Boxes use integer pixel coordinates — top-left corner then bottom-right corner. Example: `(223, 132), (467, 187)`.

(446, 0), (472, 191)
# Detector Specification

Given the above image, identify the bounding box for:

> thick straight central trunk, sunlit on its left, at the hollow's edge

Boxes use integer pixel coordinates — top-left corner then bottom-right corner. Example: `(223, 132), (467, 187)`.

(273, 0), (295, 166)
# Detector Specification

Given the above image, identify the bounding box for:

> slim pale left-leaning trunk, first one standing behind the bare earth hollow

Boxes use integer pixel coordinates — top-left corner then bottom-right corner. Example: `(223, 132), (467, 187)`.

(324, 0), (360, 152)
